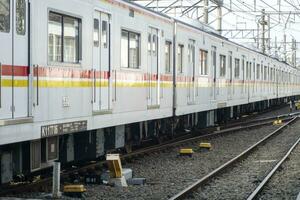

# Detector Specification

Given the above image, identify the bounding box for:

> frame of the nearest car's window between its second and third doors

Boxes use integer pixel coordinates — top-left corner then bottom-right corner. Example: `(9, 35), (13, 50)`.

(120, 27), (142, 70)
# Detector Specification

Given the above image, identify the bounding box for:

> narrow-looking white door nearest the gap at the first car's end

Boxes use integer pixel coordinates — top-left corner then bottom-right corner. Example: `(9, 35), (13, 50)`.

(148, 27), (160, 106)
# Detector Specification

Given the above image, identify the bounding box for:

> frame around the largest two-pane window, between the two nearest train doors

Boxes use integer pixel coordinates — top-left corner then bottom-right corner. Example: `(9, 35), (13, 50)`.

(47, 10), (81, 66)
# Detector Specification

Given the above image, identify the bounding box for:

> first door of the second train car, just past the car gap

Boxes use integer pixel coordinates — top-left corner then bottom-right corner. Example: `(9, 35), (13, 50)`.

(188, 40), (195, 102)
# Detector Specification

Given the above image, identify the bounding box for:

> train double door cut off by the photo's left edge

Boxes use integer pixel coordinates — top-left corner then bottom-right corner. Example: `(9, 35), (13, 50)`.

(0, 0), (29, 119)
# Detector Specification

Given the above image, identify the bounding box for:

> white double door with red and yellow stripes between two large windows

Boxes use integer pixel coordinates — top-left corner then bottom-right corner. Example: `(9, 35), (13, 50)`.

(93, 11), (111, 111)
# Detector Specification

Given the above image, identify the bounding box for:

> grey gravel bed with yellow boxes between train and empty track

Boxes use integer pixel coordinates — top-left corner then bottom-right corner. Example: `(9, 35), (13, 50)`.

(71, 126), (278, 200)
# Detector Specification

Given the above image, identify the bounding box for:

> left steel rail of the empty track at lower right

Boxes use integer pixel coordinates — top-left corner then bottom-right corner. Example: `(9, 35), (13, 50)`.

(169, 117), (297, 200)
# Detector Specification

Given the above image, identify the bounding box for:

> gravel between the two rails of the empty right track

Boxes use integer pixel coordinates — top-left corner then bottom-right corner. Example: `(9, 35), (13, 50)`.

(189, 119), (300, 199)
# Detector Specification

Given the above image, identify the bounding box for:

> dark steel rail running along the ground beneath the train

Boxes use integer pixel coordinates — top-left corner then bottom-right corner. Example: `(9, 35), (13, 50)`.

(0, 115), (291, 195)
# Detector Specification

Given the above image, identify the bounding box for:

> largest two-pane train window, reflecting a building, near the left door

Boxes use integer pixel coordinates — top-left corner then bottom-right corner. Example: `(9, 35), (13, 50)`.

(48, 12), (81, 63)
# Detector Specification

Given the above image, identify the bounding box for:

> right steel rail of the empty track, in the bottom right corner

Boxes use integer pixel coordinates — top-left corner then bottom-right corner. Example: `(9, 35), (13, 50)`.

(247, 126), (300, 200)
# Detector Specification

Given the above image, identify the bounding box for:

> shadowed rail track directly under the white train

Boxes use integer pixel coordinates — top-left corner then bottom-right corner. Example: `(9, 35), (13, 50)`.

(0, 113), (296, 196)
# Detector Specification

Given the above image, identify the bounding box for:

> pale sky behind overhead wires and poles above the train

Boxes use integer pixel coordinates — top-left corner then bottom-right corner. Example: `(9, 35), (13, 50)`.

(138, 0), (300, 65)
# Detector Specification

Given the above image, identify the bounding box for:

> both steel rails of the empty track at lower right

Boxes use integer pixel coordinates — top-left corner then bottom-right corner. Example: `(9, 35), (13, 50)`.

(169, 114), (300, 200)
